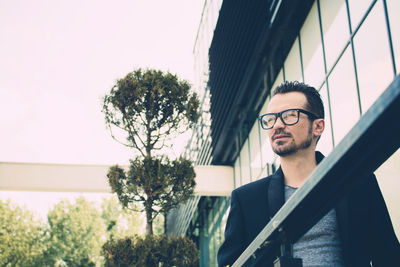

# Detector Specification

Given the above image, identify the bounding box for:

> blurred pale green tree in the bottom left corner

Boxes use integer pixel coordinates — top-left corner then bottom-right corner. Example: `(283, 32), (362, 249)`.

(0, 200), (47, 266)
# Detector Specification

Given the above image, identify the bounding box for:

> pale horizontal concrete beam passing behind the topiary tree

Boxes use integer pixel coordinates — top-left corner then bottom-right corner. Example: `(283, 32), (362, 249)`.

(0, 162), (234, 196)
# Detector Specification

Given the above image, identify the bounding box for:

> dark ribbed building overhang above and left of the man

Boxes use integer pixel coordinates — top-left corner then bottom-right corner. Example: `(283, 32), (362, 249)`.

(208, 0), (314, 165)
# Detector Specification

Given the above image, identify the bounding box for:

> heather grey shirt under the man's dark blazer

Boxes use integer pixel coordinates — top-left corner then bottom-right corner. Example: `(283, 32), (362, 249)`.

(285, 185), (344, 267)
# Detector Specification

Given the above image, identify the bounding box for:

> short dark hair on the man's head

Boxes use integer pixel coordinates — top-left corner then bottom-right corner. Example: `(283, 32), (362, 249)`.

(271, 81), (325, 119)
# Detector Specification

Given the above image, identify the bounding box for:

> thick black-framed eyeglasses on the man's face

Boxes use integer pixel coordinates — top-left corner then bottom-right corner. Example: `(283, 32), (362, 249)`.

(258, 108), (318, 130)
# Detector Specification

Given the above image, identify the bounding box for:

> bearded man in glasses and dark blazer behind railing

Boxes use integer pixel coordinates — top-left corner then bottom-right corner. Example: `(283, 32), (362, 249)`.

(218, 82), (400, 267)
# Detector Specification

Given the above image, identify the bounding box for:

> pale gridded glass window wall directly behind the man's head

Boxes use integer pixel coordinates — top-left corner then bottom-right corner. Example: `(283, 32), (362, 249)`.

(234, 0), (400, 191)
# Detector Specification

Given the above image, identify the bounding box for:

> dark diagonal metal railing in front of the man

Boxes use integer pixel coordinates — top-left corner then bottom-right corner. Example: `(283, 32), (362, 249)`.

(233, 75), (400, 267)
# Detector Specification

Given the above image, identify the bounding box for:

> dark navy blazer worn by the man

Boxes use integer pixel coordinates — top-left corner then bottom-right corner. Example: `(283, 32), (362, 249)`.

(218, 152), (400, 267)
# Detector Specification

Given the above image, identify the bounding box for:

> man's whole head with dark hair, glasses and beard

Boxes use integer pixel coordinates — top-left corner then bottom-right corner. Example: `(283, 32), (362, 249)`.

(260, 82), (325, 157)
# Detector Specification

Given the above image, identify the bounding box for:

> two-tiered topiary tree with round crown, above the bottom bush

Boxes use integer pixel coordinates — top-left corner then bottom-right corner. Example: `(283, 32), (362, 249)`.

(102, 69), (199, 235)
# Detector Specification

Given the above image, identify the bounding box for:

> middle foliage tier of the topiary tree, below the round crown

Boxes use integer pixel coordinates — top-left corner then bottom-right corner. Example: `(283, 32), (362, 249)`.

(107, 157), (196, 233)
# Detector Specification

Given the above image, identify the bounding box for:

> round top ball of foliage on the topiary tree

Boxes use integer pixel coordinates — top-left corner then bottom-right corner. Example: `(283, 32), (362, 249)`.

(102, 69), (199, 156)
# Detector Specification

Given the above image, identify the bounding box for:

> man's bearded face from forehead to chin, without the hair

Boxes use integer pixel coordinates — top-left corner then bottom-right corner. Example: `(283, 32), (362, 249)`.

(267, 92), (313, 157)
